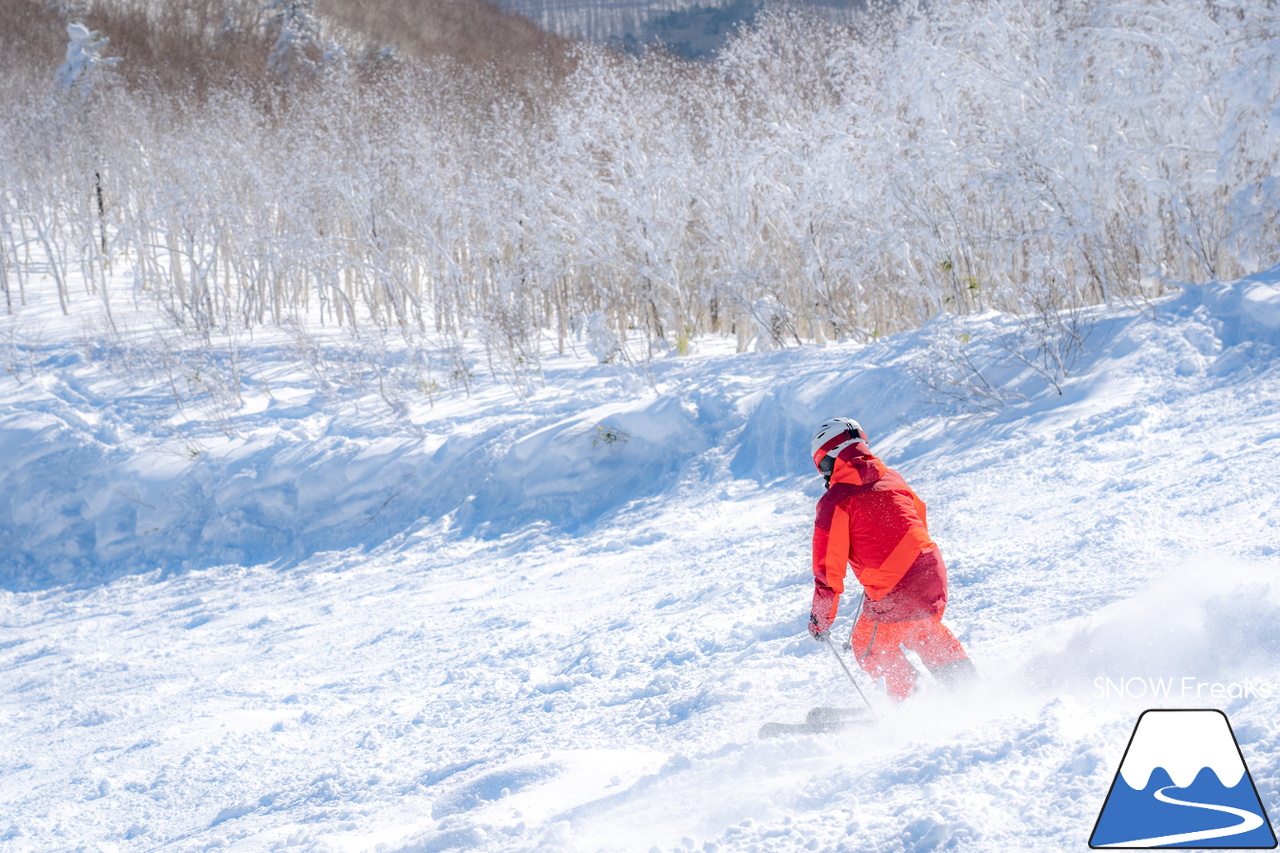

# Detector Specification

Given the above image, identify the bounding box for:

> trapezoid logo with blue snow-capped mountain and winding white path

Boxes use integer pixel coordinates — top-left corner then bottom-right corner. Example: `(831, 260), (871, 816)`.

(1089, 710), (1276, 850)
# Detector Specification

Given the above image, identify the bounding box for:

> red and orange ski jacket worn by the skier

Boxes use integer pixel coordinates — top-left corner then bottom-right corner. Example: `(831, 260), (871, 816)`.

(812, 441), (947, 628)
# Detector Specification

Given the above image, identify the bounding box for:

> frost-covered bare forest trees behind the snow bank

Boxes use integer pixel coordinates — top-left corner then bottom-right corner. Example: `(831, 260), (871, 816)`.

(0, 0), (1280, 379)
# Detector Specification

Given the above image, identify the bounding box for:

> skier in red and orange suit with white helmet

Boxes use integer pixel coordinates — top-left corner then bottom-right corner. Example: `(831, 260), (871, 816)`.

(809, 418), (977, 702)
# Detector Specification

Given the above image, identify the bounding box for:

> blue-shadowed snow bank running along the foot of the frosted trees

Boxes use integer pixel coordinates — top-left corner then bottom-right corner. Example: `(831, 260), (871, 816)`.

(20, 262), (1280, 589)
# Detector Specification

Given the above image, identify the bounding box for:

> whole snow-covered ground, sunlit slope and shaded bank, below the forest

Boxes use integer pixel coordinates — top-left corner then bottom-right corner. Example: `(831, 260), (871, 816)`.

(0, 268), (1280, 853)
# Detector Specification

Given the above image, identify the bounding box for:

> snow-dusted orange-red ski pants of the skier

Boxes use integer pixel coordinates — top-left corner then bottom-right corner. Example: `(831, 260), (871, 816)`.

(852, 613), (969, 702)
